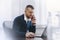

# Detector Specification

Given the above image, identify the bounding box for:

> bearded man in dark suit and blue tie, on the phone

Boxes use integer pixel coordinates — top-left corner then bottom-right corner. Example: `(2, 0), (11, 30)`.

(13, 5), (36, 37)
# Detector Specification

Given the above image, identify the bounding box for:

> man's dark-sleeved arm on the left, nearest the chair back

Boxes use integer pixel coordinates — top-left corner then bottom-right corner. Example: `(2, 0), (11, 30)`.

(13, 18), (25, 36)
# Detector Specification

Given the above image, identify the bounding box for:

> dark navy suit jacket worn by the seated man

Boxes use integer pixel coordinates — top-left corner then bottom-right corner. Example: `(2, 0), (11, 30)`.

(13, 14), (36, 34)
